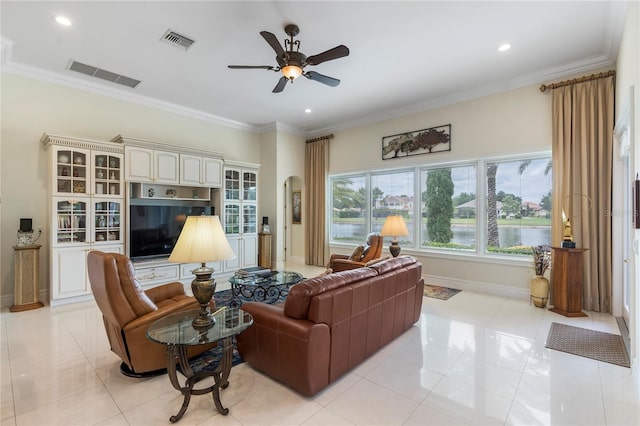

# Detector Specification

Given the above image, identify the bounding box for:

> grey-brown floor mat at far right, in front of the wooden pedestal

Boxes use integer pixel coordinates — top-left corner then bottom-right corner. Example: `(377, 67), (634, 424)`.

(545, 322), (631, 368)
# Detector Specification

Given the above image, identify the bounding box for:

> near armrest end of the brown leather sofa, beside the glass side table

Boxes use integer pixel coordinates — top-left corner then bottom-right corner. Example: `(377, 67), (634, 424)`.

(236, 302), (331, 396)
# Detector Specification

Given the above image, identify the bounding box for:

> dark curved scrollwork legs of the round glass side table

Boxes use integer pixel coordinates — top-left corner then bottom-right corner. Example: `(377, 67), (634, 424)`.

(167, 337), (233, 423)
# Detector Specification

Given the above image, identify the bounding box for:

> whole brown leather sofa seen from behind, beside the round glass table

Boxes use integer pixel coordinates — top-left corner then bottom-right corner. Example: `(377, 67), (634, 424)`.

(237, 256), (424, 396)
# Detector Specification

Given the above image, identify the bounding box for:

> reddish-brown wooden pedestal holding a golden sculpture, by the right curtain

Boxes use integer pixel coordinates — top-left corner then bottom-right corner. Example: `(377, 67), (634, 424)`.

(549, 247), (588, 317)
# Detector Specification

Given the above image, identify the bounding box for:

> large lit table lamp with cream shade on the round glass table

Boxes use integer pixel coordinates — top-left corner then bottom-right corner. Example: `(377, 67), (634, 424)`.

(169, 215), (236, 328)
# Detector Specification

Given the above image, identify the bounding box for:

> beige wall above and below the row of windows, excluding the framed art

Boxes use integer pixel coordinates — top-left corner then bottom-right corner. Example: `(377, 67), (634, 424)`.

(329, 85), (551, 296)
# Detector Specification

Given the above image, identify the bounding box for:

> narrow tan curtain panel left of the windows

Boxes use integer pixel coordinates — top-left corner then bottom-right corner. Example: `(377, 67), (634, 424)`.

(305, 138), (329, 266)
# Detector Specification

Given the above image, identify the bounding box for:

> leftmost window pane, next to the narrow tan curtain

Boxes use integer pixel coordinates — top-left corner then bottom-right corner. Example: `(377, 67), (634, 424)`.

(331, 175), (368, 244)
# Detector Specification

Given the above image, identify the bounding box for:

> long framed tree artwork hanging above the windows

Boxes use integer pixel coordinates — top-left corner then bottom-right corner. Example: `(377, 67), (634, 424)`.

(382, 124), (451, 160)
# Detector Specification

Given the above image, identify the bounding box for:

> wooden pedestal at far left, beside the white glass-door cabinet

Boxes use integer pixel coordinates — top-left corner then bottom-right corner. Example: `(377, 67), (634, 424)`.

(9, 245), (44, 312)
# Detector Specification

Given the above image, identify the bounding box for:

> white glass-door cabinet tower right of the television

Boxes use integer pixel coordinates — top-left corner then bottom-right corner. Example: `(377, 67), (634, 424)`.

(222, 164), (258, 270)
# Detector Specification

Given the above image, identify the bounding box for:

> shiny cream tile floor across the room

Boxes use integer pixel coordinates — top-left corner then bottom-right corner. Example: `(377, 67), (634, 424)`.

(0, 265), (640, 426)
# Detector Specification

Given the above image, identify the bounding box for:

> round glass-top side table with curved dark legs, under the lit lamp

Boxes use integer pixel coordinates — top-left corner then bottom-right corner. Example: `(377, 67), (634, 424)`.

(147, 308), (253, 423)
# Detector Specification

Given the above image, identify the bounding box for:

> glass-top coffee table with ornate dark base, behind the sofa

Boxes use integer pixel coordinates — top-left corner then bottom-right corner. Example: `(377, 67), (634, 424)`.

(229, 271), (304, 306)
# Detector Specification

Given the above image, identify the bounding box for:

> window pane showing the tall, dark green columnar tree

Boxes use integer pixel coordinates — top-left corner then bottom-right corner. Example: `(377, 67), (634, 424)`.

(420, 165), (477, 250)
